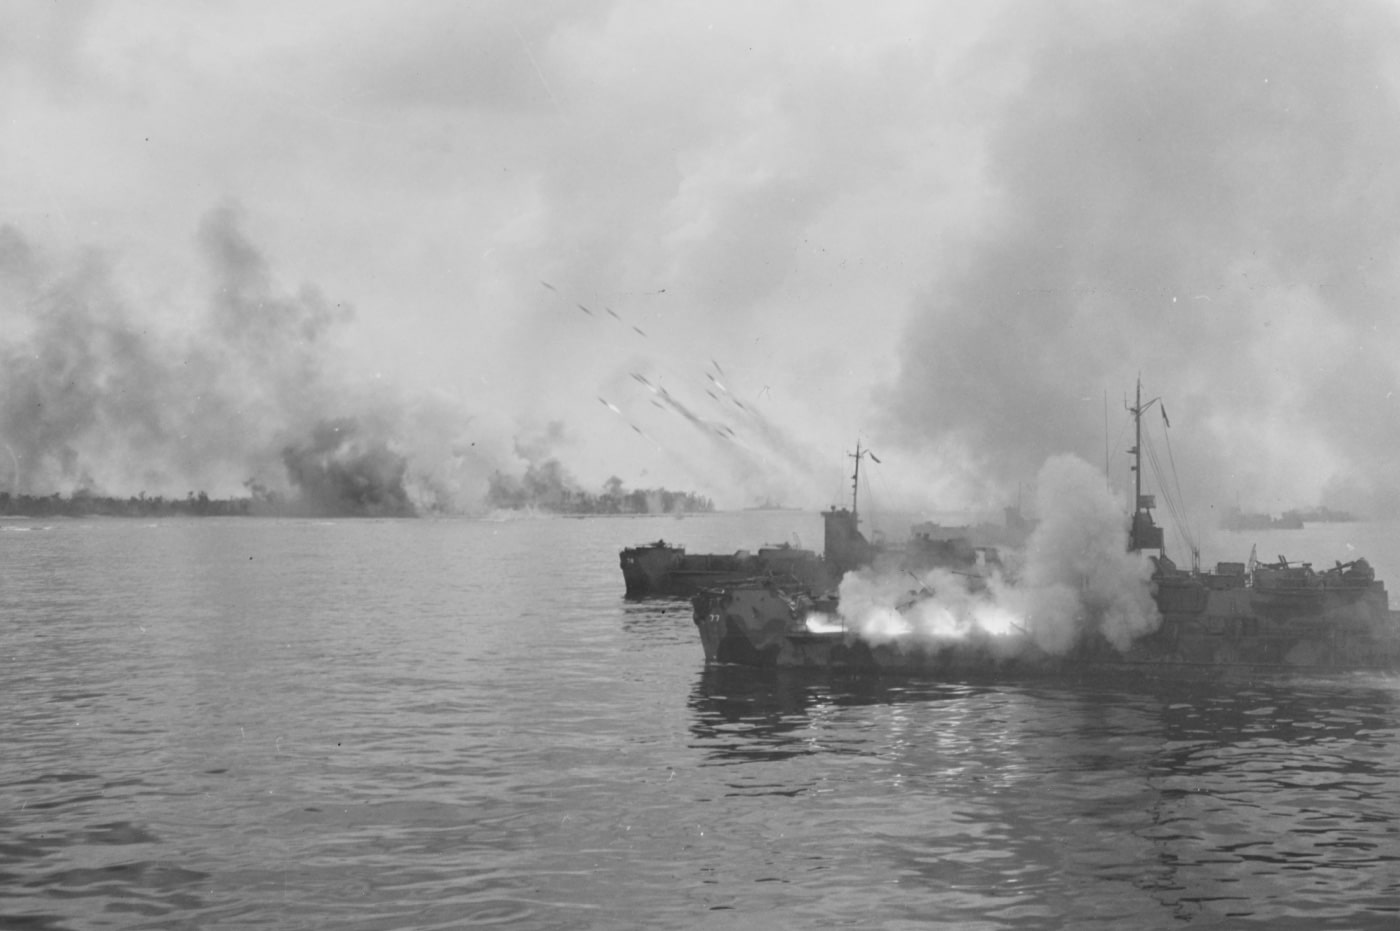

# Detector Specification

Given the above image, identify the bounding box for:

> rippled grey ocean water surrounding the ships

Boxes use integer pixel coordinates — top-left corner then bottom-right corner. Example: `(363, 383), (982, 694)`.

(0, 512), (1400, 930)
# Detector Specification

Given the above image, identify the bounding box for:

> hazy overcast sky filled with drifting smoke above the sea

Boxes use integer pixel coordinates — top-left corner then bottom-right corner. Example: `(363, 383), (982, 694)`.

(0, 0), (1400, 515)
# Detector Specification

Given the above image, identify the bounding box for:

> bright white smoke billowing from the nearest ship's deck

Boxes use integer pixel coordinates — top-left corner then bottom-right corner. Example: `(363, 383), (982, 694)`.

(816, 455), (1161, 655)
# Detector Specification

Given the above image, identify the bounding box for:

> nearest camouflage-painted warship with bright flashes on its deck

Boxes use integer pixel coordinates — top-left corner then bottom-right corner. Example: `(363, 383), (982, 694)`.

(692, 382), (1400, 676)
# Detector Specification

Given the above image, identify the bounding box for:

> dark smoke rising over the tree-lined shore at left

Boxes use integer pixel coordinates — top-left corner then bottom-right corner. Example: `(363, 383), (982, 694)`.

(0, 207), (596, 517)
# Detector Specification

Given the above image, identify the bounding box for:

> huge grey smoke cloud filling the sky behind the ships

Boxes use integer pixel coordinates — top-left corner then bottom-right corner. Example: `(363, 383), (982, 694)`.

(886, 1), (1400, 514)
